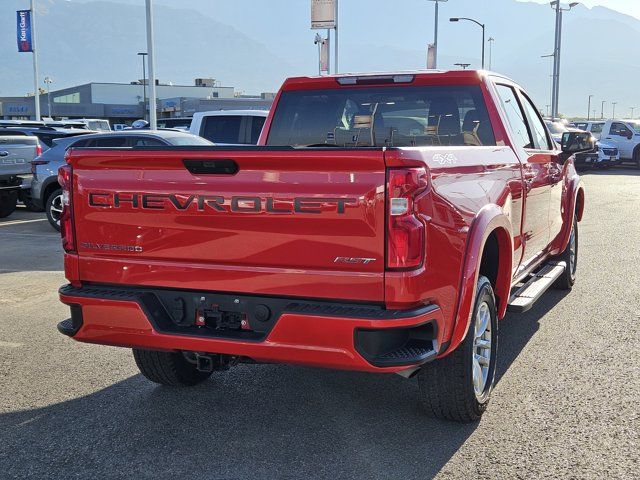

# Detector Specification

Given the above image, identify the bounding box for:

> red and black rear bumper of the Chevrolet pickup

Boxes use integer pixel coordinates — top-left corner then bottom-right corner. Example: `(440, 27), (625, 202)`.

(58, 285), (444, 372)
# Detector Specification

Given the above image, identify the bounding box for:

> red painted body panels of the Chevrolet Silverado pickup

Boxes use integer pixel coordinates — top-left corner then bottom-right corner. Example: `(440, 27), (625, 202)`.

(63, 71), (584, 371)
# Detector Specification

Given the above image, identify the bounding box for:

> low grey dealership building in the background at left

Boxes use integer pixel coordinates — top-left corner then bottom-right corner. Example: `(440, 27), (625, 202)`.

(0, 78), (274, 124)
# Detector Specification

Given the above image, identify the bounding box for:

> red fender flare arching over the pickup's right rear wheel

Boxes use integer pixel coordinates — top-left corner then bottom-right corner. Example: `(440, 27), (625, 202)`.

(441, 204), (513, 356)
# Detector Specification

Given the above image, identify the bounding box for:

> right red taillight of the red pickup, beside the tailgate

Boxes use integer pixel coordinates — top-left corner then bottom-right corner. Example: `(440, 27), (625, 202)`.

(387, 167), (427, 270)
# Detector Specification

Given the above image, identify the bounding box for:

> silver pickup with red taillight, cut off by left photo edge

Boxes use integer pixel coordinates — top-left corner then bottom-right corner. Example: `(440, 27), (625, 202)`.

(0, 135), (42, 218)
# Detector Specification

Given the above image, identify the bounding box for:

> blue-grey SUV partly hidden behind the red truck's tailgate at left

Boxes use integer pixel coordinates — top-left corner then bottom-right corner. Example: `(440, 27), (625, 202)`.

(31, 130), (213, 230)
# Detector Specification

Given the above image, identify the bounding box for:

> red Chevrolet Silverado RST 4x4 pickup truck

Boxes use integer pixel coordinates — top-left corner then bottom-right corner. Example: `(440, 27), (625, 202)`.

(58, 71), (593, 421)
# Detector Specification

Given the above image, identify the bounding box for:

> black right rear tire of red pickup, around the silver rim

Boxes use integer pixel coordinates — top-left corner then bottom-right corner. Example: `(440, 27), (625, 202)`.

(418, 276), (498, 422)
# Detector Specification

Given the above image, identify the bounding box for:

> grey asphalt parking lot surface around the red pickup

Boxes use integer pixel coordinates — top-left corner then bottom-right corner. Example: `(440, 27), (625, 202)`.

(0, 169), (640, 480)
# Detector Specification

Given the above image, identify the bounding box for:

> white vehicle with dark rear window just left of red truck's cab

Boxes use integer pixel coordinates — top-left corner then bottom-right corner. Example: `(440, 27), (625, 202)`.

(189, 110), (269, 145)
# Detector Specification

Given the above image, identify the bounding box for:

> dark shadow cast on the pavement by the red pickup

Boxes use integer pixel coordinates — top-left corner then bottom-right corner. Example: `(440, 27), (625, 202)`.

(0, 291), (565, 480)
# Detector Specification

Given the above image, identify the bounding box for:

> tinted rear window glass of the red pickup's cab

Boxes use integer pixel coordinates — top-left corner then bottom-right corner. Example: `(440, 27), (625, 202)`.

(267, 86), (495, 147)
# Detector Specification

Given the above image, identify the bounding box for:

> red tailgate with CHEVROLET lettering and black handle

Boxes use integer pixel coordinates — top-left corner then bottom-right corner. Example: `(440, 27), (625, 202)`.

(70, 147), (385, 302)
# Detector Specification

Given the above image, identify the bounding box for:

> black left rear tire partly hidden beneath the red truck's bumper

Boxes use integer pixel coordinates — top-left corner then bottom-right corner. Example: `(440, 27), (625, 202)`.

(133, 348), (211, 387)
